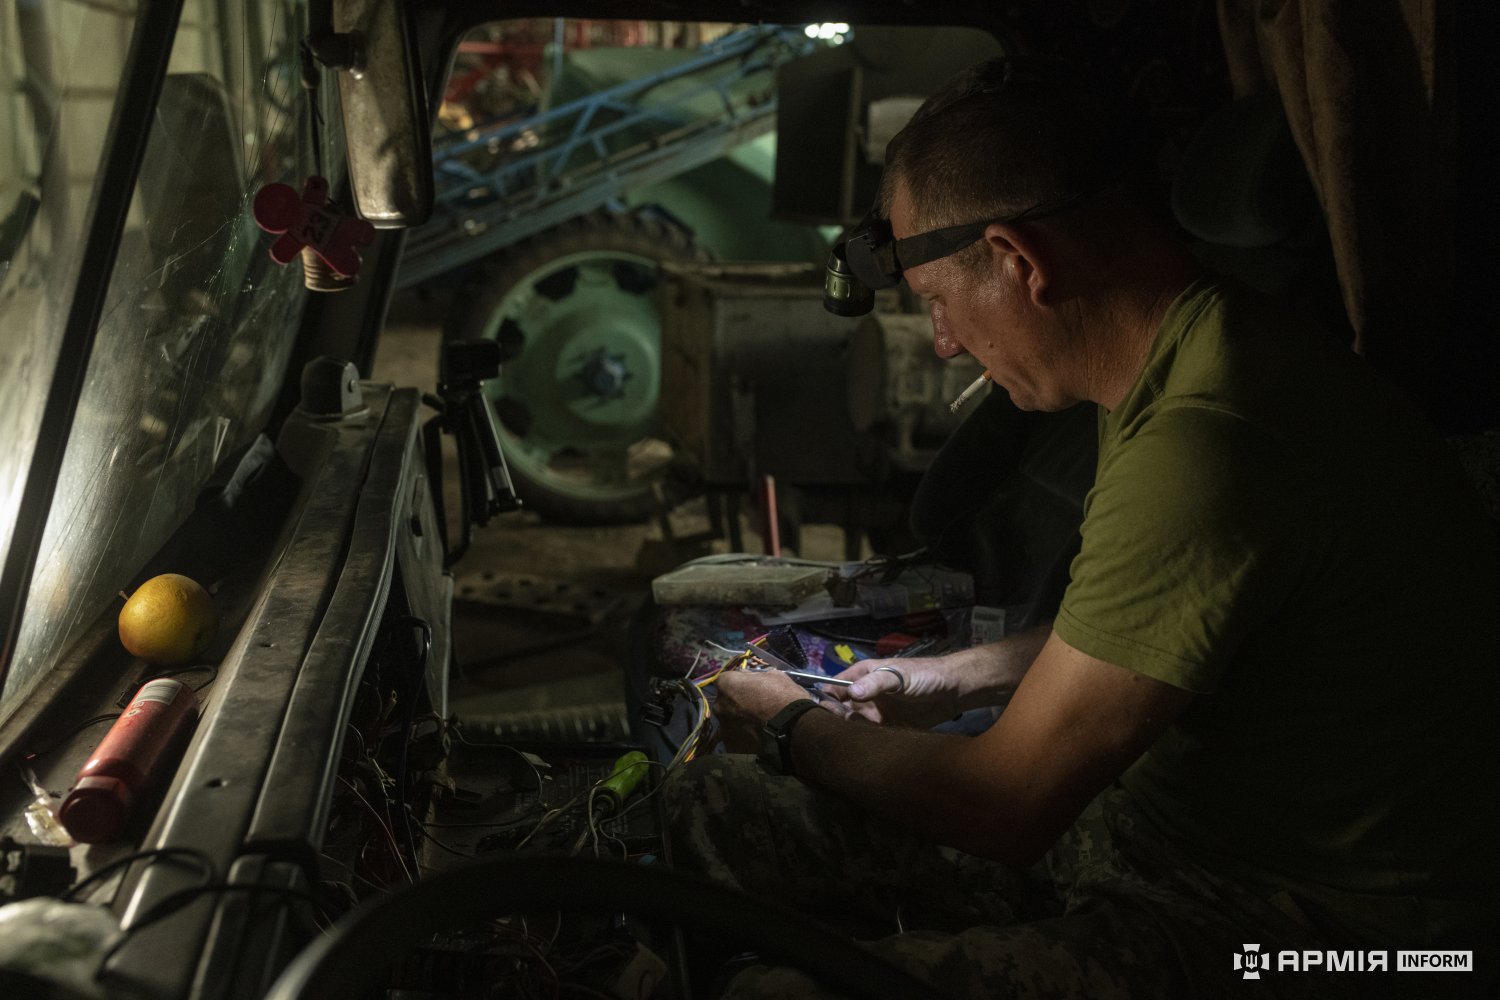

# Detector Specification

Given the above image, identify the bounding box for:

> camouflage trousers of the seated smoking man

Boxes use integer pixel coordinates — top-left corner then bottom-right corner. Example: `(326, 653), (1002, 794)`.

(662, 754), (1370, 1000)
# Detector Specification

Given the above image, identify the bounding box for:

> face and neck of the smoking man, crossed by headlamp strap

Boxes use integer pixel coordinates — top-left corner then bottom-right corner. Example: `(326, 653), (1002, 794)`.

(891, 184), (1077, 409)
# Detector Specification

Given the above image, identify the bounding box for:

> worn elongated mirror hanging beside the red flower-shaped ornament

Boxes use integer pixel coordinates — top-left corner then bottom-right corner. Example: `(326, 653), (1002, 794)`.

(318, 0), (432, 229)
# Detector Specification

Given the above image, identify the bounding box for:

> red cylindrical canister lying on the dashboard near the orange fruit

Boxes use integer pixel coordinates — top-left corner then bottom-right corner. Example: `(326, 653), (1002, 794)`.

(57, 678), (198, 844)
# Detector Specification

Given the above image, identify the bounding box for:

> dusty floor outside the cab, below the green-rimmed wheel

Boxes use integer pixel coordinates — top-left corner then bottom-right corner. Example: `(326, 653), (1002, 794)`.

(371, 292), (843, 726)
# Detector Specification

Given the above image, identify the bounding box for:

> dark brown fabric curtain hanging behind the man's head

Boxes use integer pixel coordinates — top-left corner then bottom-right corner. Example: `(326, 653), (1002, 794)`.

(1218, 0), (1457, 402)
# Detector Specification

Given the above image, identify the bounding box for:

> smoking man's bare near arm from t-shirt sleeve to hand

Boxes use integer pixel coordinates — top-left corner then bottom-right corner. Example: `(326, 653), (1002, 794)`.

(720, 634), (1193, 867)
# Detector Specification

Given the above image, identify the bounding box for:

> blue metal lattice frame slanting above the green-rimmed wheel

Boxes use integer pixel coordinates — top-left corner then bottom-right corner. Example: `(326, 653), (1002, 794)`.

(396, 25), (825, 288)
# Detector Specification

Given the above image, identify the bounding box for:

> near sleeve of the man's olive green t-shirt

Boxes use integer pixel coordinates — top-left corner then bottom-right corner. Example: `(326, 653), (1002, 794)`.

(1055, 405), (1314, 691)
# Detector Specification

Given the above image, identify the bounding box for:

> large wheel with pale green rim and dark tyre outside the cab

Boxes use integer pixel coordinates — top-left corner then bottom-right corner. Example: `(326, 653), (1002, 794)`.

(444, 211), (710, 525)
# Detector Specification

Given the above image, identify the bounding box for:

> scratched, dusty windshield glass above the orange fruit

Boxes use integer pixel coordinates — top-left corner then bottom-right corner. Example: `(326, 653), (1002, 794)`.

(0, 0), (338, 721)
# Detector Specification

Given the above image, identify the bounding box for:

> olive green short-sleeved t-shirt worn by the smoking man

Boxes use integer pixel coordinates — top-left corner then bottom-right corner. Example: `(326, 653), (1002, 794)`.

(1056, 279), (1500, 948)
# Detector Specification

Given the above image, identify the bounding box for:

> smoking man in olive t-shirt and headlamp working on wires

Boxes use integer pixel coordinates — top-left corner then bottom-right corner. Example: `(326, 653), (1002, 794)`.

(665, 60), (1500, 1000)
